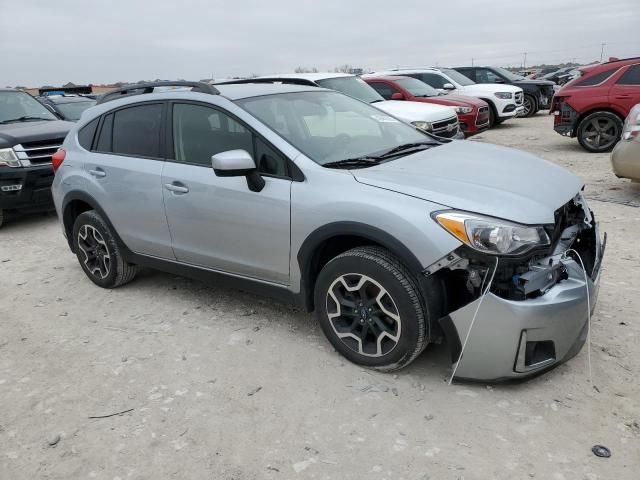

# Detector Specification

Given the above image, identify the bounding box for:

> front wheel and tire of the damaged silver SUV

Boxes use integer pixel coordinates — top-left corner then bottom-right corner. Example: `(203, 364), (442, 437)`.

(315, 247), (430, 371)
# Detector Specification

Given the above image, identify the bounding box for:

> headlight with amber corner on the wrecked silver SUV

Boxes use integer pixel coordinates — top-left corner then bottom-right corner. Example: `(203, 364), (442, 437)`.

(433, 211), (550, 255)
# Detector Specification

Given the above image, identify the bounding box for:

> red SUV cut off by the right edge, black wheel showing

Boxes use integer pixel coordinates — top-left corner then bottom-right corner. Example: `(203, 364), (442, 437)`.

(551, 57), (640, 152)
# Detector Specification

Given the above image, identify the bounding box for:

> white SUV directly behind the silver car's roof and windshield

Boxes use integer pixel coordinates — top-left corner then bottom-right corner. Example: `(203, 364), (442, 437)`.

(217, 73), (464, 139)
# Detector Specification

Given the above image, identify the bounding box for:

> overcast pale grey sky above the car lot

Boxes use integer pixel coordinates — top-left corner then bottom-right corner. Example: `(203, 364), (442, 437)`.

(0, 0), (640, 86)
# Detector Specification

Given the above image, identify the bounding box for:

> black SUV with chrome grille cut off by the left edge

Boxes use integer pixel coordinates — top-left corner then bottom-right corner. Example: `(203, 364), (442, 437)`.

(0, 89), (73, 226)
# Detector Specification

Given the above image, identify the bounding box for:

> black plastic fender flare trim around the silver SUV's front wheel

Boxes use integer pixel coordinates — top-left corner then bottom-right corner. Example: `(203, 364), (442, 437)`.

(297, 221), (424, 311)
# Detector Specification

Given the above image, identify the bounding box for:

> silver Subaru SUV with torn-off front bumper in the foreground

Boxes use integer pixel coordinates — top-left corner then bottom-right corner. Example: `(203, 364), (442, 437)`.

(53, 82), (604, 380)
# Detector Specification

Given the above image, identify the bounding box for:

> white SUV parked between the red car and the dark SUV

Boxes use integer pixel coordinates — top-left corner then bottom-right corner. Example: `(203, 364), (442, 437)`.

(372, 68), (524, 126)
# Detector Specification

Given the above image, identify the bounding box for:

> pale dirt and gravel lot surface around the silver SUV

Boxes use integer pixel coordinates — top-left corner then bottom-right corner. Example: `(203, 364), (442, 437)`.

(0, 114), (640, 480)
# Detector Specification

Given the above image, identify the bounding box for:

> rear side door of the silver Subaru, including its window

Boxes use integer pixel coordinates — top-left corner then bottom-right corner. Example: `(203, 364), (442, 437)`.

(85, 102), (174, 259)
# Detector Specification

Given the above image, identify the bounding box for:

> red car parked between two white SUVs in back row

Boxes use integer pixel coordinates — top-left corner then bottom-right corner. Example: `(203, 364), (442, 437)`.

(364, 76), (489, 135)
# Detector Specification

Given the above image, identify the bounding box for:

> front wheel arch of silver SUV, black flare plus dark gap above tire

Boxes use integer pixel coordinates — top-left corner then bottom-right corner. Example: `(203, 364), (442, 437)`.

(297, 222), (423, 312)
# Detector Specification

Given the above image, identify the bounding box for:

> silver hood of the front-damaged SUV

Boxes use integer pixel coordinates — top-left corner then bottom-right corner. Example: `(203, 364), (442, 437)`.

(351, 141), (583, 224)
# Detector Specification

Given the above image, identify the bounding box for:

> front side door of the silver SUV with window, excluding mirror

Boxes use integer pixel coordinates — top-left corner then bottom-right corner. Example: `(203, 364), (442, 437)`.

(162, 102), (291, 284)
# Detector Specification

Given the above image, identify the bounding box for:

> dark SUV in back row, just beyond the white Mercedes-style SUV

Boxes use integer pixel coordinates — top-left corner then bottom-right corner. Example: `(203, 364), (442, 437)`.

(455, 67), (553, 117)
